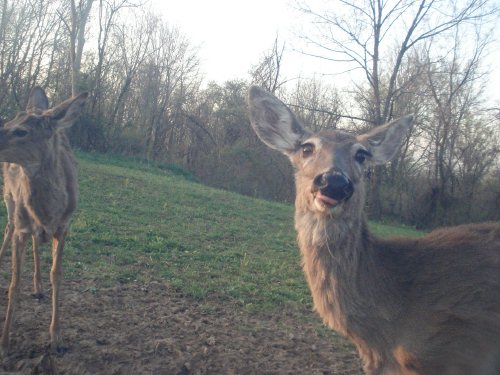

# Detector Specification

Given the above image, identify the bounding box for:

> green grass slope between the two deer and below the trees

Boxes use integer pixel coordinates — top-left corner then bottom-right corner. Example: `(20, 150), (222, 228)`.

(1, 153), (426, 311)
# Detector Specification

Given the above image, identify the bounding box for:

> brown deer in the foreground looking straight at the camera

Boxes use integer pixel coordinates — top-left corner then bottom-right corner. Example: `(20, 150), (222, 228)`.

(248, 86), (500, 375)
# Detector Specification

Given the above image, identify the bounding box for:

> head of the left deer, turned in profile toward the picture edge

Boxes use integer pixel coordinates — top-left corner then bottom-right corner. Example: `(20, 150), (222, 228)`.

(0, 87), (88, 165)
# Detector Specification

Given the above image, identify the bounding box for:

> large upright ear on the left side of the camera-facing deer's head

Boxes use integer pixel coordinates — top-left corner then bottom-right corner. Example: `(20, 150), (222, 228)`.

(248, 86), (307, 154)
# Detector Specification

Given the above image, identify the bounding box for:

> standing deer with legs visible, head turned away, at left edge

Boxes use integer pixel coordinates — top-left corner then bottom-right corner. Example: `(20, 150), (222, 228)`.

(0, 86), (88, 357)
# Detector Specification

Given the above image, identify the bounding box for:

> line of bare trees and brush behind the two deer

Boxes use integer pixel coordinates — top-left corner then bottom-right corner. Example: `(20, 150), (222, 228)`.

(0, 0), (500, 227)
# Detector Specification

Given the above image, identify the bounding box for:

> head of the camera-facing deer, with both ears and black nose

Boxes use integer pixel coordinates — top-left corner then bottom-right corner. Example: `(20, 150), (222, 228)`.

(249, 86), (413, 216)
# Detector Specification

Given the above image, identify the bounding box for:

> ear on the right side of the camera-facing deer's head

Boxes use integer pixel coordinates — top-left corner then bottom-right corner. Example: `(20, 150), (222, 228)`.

(357, 116), (413, 164)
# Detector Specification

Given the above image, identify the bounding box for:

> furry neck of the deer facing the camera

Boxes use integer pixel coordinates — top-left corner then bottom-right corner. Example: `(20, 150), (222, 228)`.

(295, 204), (397, 340)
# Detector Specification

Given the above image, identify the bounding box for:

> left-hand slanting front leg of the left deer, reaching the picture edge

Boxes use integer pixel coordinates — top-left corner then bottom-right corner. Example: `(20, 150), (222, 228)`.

(0, 233), (28, 356)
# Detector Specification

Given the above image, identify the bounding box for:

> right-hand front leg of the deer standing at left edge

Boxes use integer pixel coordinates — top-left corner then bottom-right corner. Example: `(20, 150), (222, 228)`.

(50, 228), (67, 352)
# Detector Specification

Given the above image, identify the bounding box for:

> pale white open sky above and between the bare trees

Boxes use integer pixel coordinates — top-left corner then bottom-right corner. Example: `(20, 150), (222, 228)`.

(152, 0), (500, 106)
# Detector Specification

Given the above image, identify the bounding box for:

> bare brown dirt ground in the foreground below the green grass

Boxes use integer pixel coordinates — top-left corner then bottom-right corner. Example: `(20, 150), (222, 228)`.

(0, 272), (361, 375)
